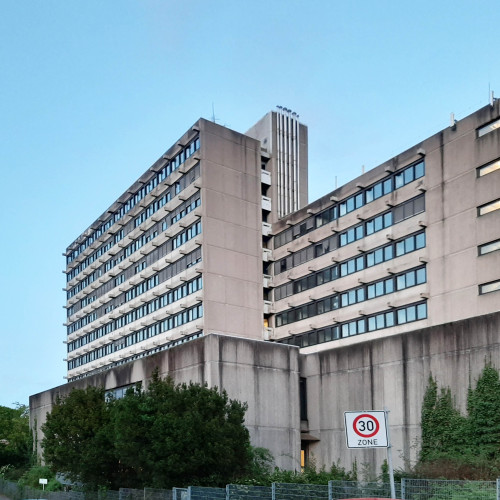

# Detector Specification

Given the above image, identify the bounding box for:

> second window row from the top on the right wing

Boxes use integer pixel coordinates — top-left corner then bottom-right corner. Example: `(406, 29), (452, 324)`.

(274, 195), (425, 276)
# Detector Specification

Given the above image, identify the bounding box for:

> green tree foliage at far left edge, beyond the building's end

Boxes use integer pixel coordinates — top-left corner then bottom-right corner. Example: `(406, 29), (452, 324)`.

(0, 405), (33, 477)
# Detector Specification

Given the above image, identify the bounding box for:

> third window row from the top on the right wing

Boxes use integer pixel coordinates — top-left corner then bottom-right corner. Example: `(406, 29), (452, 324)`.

(274, 231), (425, 301)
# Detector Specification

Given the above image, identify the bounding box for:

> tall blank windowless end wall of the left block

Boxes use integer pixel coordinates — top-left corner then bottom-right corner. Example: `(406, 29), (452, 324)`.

(199, 120), (263, 339)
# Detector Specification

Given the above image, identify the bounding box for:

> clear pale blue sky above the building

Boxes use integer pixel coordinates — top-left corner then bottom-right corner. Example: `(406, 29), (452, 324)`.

(0, 0), (500, 407)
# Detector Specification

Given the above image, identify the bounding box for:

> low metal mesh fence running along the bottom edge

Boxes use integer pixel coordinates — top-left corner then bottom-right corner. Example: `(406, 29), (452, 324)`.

(0, 479), (500, 500)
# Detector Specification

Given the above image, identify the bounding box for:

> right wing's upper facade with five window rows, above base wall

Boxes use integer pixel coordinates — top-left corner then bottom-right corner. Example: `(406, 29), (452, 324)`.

(270, 100), (500, 352)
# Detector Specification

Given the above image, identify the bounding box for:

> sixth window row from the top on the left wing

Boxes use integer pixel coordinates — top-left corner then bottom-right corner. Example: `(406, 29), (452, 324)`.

(67, 277), (202, 352)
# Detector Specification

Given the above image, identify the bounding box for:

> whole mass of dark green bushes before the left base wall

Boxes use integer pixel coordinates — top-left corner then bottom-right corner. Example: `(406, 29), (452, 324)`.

(42, 371), (252, 489)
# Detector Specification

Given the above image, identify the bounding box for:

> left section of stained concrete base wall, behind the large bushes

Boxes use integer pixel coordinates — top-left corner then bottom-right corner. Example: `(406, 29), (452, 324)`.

(30, 335), (300, 469)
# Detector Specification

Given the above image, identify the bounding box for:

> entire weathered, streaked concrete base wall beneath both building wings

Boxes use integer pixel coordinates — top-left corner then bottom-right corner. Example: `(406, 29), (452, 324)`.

(30, 312), (500, 473)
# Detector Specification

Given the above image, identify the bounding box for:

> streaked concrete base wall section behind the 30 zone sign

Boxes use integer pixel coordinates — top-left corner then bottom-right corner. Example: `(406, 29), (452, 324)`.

(300, 313), (500, 473)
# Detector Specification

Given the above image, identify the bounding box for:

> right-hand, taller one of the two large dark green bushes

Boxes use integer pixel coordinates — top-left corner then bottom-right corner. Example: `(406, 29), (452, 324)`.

(114, 371), (252, 488)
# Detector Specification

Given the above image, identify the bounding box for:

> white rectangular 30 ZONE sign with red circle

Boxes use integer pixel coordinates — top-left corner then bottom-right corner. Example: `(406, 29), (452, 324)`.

(344, 411), (389, 448)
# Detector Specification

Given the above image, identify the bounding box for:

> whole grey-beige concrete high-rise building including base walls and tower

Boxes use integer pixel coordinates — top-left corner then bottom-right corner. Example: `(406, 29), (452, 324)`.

(30, 100), (500, 468)
